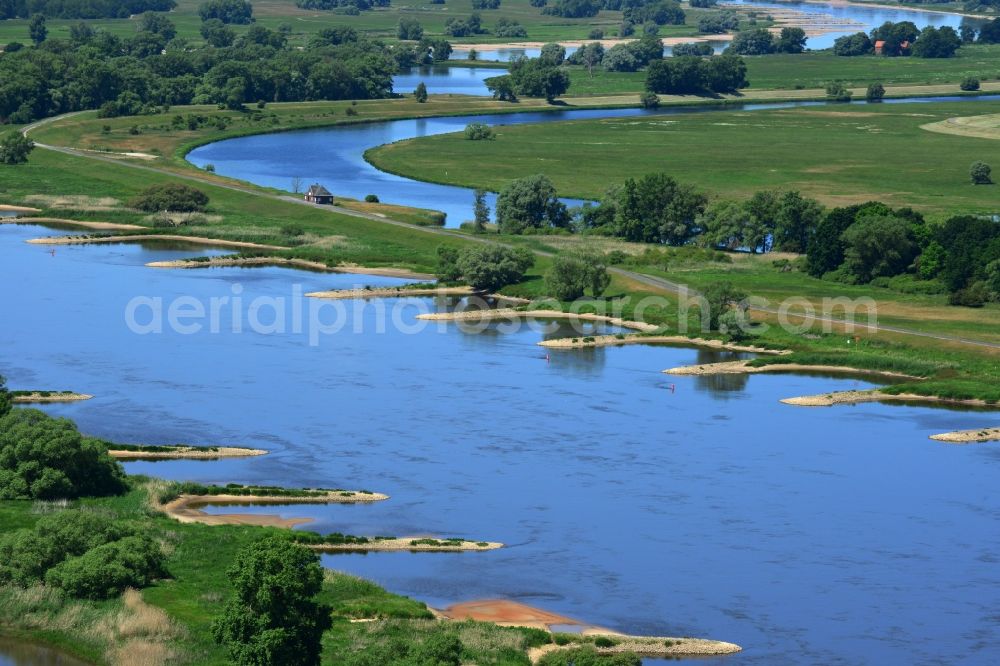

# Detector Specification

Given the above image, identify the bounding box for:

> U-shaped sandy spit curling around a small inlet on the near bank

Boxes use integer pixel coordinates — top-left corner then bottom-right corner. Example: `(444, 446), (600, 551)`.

(155, 491), (389, 527)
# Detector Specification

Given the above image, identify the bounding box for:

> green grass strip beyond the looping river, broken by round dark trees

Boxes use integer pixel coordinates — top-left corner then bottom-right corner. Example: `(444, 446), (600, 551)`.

(570, 44), (1000, 95)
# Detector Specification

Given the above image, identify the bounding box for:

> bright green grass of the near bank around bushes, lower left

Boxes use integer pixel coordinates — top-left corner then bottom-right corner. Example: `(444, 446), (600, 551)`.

(0, 477), (538, 666)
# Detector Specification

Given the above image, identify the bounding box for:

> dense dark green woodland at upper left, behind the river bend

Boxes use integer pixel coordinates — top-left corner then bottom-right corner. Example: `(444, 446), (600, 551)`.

(0, 14), (426, 124)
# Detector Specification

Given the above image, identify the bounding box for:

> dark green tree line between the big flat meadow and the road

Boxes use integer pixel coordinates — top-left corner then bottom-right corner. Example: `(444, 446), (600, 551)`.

(468, 170), (1000, 307)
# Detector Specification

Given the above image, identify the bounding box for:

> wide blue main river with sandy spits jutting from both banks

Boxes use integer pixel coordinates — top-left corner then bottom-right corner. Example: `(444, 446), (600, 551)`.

(0, 225), (1000, 666)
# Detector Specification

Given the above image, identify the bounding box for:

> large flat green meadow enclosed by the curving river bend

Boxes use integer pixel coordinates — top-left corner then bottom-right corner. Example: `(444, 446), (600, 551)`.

(368, 101), (1000, 217)
